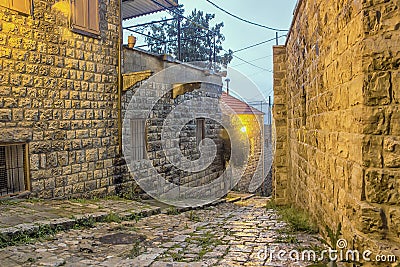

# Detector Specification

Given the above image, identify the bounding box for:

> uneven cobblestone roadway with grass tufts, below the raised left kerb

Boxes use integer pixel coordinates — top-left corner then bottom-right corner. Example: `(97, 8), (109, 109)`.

(0, 197), (320, 267)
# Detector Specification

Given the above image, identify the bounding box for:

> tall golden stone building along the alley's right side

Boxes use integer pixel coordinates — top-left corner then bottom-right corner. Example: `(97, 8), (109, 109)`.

(274, 0), (400, 260)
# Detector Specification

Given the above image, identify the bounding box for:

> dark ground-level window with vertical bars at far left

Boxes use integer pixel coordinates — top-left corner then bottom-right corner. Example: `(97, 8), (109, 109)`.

(0, 144), (27, 196)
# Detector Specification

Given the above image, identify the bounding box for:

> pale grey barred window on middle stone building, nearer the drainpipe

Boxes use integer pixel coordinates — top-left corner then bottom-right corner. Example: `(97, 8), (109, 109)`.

(131, 119), (146, 160)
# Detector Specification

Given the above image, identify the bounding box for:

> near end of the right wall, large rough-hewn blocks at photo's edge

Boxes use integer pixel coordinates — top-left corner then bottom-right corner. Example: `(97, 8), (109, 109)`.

(360, 1), (400, 249)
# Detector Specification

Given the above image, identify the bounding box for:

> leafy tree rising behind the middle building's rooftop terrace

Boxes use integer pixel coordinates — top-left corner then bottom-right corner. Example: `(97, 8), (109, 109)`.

(143, 6), (232, 65)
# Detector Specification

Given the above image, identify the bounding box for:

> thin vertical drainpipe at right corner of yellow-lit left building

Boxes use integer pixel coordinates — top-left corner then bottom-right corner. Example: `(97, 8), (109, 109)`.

(117, 0), (123, 156)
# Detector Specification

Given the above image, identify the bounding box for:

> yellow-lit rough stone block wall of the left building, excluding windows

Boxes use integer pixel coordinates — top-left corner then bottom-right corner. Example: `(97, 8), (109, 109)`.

(0, 0), (120, 198)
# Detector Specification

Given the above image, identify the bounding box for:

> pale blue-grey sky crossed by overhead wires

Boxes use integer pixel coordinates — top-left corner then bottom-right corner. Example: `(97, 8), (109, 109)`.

(124, 0), (297, 104)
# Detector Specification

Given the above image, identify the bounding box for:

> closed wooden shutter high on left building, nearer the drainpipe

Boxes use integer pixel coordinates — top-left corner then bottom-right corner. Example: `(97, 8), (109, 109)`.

(71, 0), (100, 34)
